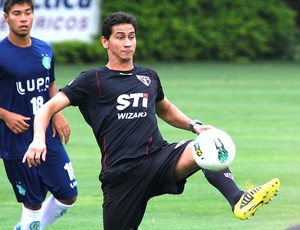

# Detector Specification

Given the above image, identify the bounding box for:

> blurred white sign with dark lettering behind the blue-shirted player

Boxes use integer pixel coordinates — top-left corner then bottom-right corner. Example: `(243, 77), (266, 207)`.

(0, 0), (101, 42)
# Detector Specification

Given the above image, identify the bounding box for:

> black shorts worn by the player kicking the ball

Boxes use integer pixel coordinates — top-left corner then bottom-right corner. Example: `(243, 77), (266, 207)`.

(100, 141), (190, 230)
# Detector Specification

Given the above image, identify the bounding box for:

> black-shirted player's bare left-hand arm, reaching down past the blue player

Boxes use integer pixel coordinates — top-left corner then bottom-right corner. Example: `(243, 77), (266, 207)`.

(23, 92), (70, 167)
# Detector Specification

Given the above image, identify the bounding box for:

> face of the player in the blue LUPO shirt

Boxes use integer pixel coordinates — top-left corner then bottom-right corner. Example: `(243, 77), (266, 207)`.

(4, 3), (33, 37)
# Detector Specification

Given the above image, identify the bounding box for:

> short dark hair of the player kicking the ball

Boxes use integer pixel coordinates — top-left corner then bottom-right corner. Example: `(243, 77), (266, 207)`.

(102, 11), (137, 39)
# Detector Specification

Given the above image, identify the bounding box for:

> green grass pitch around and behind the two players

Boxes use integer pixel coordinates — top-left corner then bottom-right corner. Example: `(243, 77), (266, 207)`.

(0, 62), (300, 230)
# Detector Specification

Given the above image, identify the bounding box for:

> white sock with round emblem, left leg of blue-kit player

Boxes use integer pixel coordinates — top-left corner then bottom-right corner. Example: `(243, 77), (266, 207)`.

(21, 205), (42, 230)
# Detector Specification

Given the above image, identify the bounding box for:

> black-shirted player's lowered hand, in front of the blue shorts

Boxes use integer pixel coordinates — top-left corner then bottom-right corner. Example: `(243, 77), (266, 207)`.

(22, 137), (46, 168)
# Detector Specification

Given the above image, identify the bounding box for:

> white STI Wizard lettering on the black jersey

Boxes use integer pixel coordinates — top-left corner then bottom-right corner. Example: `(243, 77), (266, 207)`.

(116, 93), (149, 120)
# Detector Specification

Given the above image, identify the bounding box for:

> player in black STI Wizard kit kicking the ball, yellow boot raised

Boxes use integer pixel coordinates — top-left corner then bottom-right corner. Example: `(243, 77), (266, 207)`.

(23, 12), (280, 230)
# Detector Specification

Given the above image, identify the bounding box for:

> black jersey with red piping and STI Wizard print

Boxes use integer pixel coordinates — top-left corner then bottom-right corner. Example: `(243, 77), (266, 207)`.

(61, 67), (166, 170)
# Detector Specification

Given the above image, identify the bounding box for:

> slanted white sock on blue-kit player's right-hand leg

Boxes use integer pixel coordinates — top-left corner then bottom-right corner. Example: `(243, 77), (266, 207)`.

(41, 195), (73, 228)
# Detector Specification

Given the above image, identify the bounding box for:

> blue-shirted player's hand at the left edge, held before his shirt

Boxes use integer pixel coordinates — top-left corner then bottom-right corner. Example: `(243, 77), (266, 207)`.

(4, 112), (30, 134)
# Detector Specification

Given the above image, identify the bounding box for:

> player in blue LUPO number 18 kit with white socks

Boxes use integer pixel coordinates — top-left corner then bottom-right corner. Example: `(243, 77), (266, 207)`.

(0, 0), (77, 230)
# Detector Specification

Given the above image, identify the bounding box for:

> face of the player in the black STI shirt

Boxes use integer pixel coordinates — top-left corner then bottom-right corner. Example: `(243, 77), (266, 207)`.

(102, 24), (136, 62)
